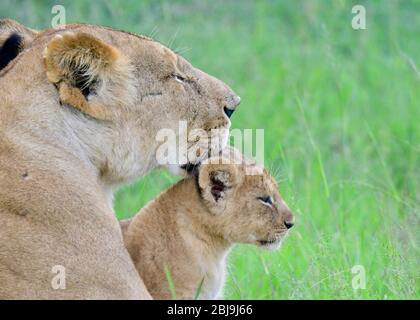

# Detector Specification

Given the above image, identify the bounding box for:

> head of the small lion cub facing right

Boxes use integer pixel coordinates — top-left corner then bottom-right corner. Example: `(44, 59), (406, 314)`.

(197, 152), (294, 249)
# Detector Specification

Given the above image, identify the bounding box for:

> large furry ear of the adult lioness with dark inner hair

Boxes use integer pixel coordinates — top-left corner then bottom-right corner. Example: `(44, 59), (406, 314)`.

(44, 33), (121, 119)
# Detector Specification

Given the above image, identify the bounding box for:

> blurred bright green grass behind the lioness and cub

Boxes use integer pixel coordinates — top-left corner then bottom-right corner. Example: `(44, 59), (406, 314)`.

(0, 0), (420, 299)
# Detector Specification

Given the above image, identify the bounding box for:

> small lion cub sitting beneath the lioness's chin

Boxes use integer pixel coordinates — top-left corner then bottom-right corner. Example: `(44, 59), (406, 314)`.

(121, 151), (293, 299)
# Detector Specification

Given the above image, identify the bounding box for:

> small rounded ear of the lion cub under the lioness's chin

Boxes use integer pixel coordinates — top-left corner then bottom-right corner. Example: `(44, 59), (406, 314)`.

(198, 162), (239, 202)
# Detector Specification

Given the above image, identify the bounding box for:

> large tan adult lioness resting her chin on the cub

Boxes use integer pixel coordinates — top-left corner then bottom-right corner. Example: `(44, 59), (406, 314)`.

(0, 24), (239, 299)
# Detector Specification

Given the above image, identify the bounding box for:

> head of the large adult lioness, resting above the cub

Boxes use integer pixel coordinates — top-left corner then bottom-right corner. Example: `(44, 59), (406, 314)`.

(41, 25), (240, 180)
